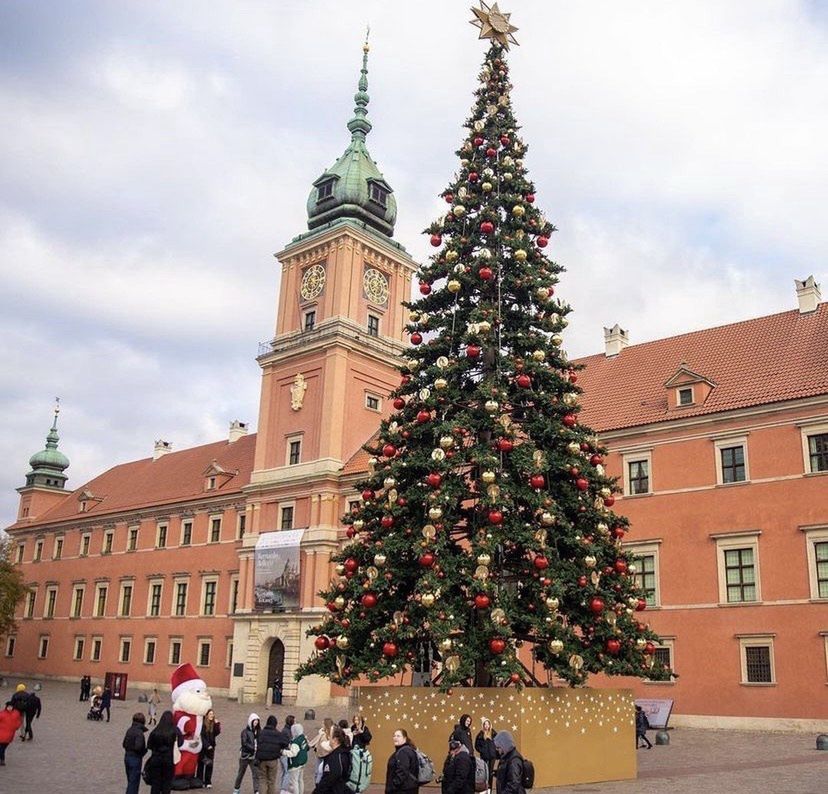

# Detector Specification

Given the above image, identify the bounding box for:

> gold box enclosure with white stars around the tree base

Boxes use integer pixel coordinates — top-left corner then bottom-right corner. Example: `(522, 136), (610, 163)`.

(358, 687), (637, 788)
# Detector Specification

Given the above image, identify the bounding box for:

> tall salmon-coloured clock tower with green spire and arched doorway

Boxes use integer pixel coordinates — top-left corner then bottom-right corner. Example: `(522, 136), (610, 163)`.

(231, 42), (417, 704)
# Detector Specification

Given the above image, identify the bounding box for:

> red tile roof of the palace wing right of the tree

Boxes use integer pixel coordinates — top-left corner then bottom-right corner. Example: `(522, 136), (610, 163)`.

(577, 303), (828, 432)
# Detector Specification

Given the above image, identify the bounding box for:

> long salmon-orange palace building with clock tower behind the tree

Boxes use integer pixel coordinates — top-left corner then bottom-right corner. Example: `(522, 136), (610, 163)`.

(0, 41), (828, 726)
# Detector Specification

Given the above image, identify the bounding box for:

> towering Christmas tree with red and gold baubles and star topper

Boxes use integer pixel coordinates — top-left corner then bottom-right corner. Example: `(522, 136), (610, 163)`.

(299, 4), (670, 688)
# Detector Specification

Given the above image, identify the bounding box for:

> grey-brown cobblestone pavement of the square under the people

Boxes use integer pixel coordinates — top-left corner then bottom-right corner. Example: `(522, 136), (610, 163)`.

(0, 679), (828, 794)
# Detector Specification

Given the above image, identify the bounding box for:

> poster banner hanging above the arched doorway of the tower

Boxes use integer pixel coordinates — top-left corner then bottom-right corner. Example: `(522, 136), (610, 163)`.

(254, 529), (305, 611)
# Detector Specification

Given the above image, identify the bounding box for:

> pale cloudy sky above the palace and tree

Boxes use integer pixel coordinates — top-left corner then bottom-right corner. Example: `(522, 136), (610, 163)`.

(0, 0), (828, 526)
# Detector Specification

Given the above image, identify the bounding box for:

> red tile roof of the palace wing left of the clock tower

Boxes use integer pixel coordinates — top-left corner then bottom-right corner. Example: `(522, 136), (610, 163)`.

(10, 433), (256, 529)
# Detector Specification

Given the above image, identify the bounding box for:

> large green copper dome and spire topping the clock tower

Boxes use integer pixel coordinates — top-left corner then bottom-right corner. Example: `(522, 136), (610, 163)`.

(308, 41), (397, 237)
